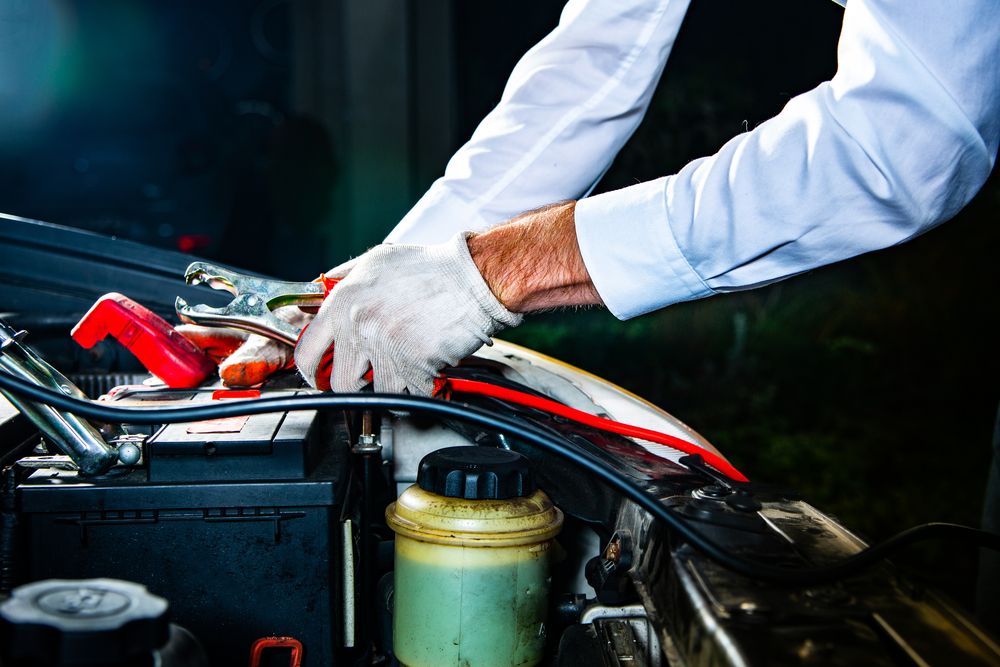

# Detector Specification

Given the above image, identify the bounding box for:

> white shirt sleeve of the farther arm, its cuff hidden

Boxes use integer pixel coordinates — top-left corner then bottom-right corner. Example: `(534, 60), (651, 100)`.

(386, 0), (688, 243)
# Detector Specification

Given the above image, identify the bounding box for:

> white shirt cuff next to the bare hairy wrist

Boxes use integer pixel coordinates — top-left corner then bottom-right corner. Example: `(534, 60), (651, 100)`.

(575, 177), (715, 320)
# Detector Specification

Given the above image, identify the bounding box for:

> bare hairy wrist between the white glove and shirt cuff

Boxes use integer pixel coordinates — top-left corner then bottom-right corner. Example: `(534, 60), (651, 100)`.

(469, 201), (601, 313)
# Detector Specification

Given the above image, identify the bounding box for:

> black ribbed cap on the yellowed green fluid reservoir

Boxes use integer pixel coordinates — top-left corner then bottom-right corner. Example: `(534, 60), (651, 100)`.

(417, 447), (535, 500)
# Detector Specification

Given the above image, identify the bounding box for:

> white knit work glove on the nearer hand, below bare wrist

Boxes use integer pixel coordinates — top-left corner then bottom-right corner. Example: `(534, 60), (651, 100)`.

(295, 234), (522, 395)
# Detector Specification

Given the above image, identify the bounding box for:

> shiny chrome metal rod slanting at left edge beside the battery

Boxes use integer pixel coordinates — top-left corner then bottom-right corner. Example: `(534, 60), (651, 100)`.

(0, 321), (118, 475)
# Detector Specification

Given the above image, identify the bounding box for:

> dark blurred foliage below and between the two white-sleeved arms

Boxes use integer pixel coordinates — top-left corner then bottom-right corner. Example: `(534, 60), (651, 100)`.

(506, 3), (1000, 604)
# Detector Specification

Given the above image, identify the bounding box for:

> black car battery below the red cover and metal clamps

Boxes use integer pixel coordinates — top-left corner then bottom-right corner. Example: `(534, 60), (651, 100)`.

(10, 390), (353, 667)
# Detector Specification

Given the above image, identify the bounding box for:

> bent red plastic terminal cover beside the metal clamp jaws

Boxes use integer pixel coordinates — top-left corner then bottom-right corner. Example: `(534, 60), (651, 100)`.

(70, 292), (215, 389)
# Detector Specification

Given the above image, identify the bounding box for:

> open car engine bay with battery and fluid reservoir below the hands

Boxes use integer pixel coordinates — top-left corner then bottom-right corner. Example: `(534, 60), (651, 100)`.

(0, 217), (1000, 667)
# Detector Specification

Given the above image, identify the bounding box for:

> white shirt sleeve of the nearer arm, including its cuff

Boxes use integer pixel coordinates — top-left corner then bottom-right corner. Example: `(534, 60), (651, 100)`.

(576, 0), (1000, 319)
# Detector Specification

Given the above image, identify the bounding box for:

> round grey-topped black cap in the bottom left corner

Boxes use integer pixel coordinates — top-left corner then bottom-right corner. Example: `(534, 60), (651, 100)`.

(0, 579), (170, 667)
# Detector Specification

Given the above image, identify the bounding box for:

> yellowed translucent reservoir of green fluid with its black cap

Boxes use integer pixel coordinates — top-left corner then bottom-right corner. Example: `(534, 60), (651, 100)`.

(385, 447), (562, 667)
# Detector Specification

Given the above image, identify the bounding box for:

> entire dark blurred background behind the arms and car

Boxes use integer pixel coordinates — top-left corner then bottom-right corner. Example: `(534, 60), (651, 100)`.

(0, 0), (1000, 603)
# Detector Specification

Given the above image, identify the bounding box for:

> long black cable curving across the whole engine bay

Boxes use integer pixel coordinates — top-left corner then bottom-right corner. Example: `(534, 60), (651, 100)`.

(0, 373), (1000, 586)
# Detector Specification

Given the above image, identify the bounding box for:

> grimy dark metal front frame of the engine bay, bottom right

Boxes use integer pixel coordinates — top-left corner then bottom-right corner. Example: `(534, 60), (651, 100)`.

(612, 498), (1000, 667)
